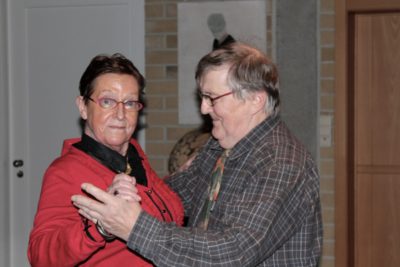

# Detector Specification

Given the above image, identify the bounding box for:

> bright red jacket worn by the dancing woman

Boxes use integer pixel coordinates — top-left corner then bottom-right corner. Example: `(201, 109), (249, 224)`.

(28, 138), (183, 267)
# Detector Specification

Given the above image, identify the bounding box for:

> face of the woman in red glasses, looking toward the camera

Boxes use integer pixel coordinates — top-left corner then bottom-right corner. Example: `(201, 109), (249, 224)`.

(77, 73), (139, 155)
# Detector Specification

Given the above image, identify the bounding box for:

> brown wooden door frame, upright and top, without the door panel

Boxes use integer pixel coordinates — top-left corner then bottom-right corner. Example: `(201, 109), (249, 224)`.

(335, 0), (400, 267)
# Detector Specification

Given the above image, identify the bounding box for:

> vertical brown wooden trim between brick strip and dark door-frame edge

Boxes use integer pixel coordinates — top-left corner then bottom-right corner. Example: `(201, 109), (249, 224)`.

(335, 0), (349, 267)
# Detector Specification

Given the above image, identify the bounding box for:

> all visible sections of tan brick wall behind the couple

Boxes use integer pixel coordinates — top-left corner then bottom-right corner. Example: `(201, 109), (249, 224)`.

(145, 0), (335, 267)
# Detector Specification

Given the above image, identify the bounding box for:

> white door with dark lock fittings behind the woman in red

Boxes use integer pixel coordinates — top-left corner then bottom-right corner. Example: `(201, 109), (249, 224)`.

(0, 0), (144, 267)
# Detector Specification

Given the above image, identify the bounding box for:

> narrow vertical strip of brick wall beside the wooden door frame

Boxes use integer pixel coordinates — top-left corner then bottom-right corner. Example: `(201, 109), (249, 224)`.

(319, 0), (335, 267)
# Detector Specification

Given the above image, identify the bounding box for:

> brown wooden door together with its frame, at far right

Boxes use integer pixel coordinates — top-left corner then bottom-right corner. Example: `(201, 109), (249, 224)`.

(335, 0), (400, 267)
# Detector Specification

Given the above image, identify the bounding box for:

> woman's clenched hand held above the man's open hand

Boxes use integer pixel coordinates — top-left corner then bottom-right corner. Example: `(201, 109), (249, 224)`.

(107, 173), (141, 202)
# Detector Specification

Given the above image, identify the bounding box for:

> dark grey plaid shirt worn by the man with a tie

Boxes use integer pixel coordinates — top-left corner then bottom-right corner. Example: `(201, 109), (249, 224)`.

(127, 116), (322, 267)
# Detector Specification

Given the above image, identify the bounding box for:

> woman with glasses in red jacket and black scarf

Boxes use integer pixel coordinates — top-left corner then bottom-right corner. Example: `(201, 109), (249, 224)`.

(28, 54), (183, 267)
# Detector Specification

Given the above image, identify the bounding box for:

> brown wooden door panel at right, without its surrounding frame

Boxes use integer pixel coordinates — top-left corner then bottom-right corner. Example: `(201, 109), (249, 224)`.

(353, 12), (400, 267)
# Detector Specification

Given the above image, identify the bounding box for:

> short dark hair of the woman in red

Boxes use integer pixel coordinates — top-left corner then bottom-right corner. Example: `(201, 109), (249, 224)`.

(79, 53), (146, 102)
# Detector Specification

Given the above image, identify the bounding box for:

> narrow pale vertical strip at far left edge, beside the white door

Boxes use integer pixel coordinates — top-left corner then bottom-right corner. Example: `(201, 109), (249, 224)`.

(0, 0), (10, 267)
